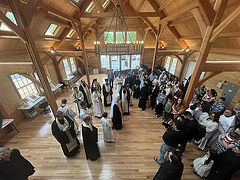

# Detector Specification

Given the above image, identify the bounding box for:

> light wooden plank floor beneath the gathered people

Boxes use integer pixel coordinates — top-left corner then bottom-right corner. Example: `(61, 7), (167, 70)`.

(0, 75), (203, 180)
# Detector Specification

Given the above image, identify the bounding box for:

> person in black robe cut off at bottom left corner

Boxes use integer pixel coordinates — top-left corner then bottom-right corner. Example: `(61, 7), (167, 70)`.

(0, 147), (35, 180)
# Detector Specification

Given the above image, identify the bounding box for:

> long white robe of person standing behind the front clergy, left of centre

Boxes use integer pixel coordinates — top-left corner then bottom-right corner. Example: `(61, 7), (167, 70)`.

(92, 91), (103, 117)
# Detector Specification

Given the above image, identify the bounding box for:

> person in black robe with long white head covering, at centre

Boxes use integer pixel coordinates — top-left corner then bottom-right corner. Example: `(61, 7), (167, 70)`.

(110, 92), (123, 130)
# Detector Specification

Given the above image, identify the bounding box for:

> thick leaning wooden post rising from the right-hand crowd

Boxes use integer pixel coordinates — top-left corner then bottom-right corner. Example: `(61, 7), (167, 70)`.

(184, 0), (227, 107)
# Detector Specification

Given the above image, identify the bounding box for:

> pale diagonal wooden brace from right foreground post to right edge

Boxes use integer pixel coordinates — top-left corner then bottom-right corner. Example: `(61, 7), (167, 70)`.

(210, 6), (240, 42)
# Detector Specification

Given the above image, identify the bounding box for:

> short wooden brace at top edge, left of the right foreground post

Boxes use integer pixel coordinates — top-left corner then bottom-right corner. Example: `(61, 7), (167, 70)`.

(197, 0), (216, 26)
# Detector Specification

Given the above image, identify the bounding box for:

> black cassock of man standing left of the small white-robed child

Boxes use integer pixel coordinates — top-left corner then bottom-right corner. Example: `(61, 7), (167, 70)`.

(82, 125), (100, 161)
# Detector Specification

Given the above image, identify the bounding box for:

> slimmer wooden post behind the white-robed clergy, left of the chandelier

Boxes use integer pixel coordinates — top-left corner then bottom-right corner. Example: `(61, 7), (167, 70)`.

(72, 20), (91, 87)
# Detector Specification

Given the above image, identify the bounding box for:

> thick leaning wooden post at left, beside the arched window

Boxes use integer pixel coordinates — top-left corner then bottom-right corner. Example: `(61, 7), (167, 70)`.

(8, 0), (58, 114)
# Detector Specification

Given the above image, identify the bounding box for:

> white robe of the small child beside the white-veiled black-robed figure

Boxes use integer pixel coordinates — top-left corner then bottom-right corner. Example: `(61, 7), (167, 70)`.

(100, 117), (114, 142)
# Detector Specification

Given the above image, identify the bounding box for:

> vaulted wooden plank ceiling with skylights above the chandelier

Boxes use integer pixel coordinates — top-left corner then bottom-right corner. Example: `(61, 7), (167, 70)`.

(0, 0), (240, 55)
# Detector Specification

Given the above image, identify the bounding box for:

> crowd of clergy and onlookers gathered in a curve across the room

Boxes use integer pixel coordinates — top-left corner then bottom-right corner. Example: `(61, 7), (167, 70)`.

(0, 69), (240, 180)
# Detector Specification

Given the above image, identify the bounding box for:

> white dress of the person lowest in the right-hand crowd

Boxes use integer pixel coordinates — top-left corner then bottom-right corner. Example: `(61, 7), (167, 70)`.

(193, 154), (214, 177)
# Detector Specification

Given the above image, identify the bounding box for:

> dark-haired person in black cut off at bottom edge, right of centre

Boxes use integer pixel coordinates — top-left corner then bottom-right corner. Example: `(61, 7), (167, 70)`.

(153, 152), (184, 180)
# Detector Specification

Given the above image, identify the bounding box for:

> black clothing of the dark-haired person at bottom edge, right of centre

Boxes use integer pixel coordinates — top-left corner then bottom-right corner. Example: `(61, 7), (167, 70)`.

(153, 161), (184, 180)
